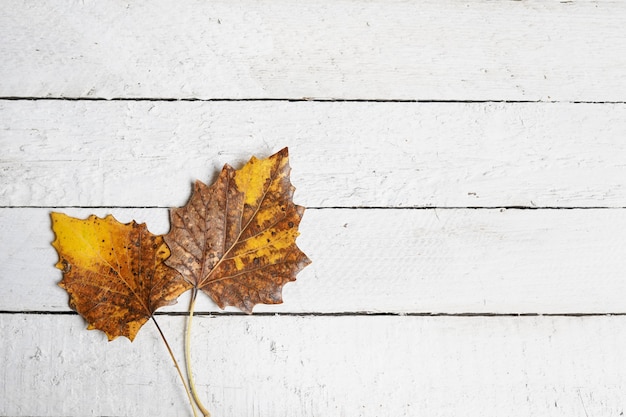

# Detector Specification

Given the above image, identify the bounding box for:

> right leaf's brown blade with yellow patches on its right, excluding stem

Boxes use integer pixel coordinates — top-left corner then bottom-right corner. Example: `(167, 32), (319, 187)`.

(164, 148), (310, 313)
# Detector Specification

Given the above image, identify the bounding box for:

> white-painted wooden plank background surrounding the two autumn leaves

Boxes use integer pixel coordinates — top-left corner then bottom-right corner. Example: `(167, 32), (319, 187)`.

(0, 0), (626, 417)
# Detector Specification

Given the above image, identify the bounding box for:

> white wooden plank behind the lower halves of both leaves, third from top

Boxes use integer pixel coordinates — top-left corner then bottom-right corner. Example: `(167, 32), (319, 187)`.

(0, 209), (626, 313)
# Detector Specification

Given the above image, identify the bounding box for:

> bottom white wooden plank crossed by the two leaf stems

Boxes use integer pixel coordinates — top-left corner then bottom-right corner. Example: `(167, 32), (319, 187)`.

(0, 314), (626, 417)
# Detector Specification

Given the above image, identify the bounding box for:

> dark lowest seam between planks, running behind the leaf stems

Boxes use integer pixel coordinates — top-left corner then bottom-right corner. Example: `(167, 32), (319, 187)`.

(0, 310), (626, 317)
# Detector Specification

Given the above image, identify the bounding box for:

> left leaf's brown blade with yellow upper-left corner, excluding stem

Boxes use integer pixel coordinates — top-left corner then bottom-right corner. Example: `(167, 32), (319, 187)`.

(51, 213), (191, 341)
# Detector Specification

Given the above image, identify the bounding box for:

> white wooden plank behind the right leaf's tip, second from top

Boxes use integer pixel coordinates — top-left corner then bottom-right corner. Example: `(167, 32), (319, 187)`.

(0, 101), (626, 207)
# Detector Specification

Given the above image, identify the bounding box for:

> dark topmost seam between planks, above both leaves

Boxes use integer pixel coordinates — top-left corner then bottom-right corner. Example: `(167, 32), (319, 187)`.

(0, 96), (626, 104)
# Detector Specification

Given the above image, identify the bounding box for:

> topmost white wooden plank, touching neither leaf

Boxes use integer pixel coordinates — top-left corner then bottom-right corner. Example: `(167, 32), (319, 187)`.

(0, 0), (626, 101)
